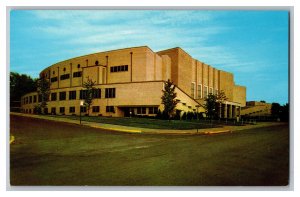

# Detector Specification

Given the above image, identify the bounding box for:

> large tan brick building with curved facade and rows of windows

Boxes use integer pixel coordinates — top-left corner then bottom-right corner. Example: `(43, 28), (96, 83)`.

(21, 46), (246, 118)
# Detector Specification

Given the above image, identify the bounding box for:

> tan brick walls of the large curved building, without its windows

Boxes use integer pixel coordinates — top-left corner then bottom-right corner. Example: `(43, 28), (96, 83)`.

(22, 46), (246, 116)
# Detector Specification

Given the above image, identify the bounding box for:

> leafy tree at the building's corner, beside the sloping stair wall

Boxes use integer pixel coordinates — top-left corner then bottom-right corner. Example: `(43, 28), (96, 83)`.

(161, 79), (179, 120)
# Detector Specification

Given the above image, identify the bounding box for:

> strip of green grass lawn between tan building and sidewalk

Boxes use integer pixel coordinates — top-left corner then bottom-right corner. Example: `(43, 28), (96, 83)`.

(47, 115), (225, 130)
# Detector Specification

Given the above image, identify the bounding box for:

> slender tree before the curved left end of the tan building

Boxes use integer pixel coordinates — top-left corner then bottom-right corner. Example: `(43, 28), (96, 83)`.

(37, 76), (50, 113)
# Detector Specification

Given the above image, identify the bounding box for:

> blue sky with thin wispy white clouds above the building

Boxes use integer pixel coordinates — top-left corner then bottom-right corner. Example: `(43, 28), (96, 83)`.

(10, 10), (288, 104)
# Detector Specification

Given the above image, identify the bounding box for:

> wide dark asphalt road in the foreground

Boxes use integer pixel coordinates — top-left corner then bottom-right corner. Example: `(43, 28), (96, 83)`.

(10, 116), (289, 186)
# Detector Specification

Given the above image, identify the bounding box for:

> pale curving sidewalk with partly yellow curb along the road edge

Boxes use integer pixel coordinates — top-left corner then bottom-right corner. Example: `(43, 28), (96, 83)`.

(10, 112), (285, 135)
